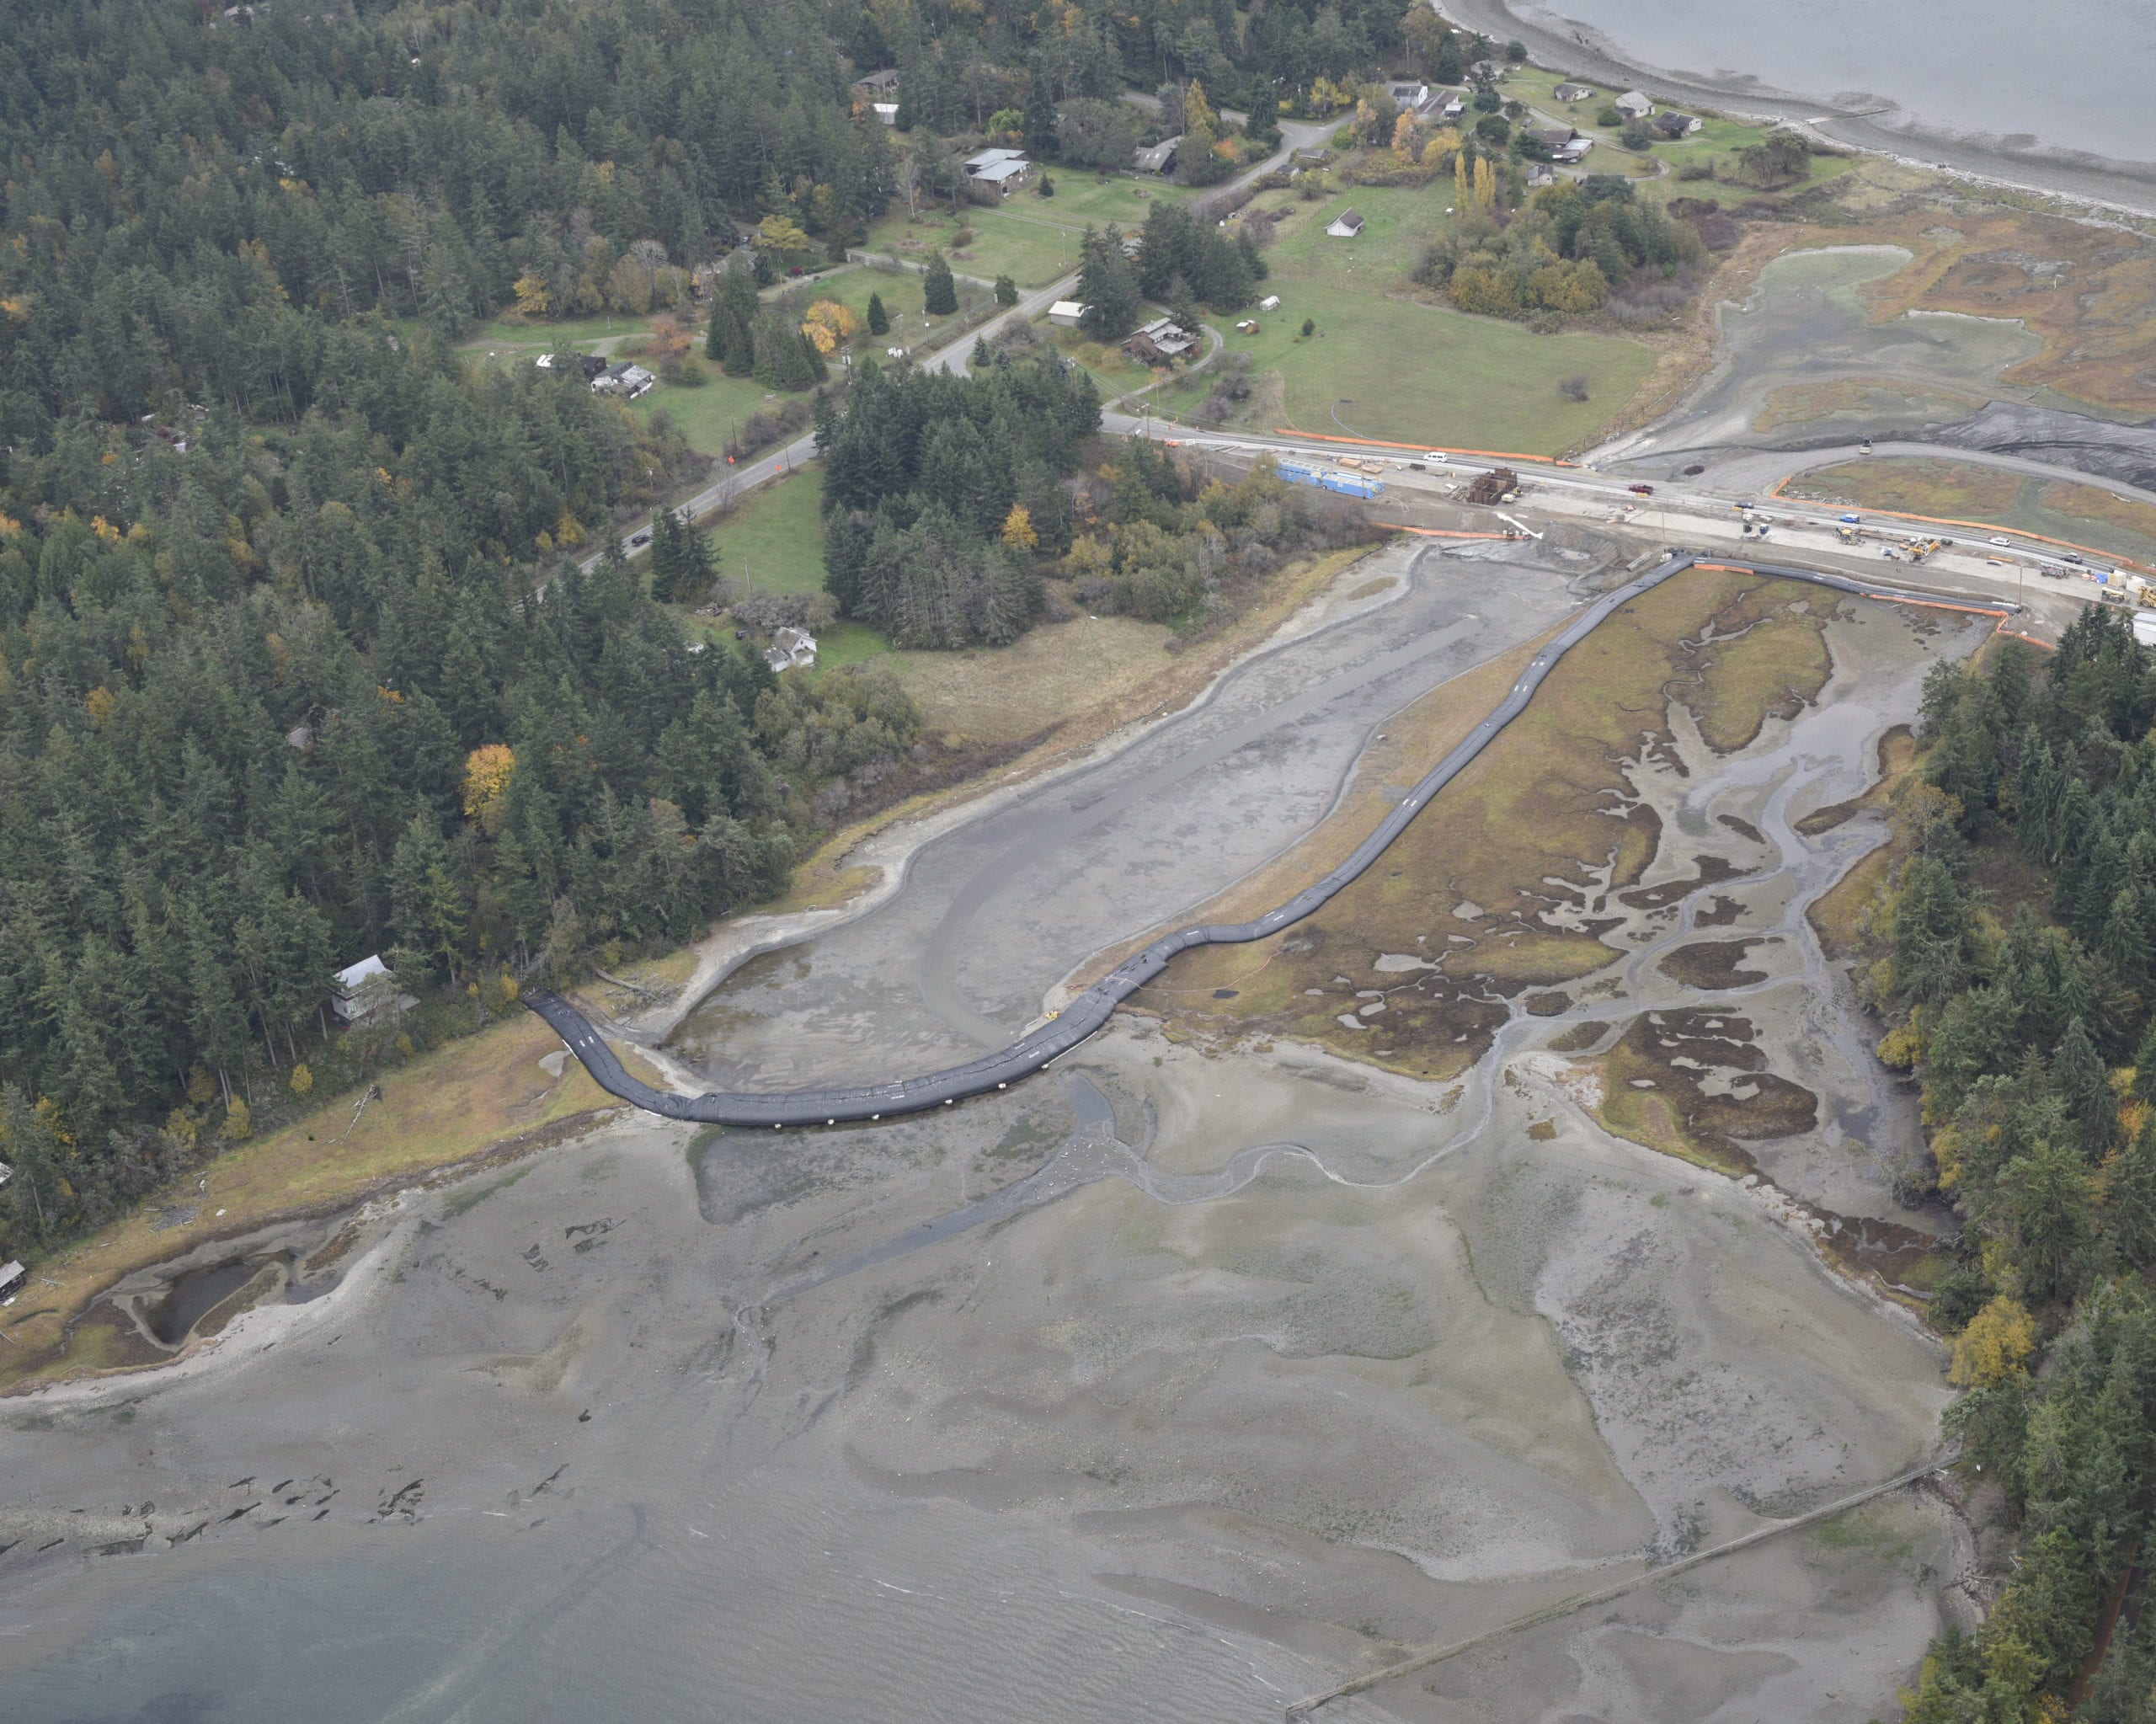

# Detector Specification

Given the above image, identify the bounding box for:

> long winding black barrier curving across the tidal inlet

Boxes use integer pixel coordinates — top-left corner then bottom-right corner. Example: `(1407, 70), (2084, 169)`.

(524, 552), (2009, 1129)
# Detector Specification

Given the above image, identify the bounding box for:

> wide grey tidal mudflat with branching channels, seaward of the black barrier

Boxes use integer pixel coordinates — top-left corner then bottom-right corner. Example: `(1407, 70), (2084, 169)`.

(0, 549), (1977, 1721)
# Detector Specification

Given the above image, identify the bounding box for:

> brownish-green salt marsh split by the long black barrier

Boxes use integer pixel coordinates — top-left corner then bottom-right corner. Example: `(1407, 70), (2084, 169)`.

(1140, 571), (1828, 1080)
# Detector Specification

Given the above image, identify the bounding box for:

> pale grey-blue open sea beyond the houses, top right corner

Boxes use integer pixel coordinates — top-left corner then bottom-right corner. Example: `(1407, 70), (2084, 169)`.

(1522, 0), (2156, 162)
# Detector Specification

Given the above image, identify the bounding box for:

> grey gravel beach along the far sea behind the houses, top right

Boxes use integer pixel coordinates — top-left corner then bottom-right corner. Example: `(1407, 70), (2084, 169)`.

(1438, 0), (2156, 216)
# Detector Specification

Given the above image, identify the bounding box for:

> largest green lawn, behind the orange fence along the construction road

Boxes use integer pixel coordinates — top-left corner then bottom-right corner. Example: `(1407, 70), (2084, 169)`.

(1173, 179), (1656, 455)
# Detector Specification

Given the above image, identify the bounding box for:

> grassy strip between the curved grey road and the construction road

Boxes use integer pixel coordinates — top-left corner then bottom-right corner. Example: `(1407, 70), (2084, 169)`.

(1785, 456), (2156, 564)
